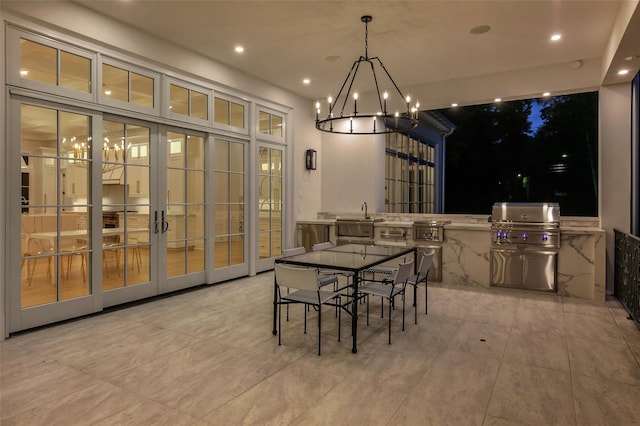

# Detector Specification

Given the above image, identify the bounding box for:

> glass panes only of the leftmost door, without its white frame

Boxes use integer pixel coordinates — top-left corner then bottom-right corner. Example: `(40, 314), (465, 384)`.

(21, 105), (91, 308)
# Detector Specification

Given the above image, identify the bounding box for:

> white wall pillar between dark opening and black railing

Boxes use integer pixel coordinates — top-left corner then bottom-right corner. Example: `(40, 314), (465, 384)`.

(598, 83), (631, 291)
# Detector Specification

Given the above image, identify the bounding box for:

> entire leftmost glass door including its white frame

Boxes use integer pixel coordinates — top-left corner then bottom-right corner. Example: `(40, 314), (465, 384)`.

(6, 98), (100, 332)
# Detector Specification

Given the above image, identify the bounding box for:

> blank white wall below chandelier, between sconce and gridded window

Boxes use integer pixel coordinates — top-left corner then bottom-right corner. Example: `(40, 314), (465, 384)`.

(318, 133), (385, 213)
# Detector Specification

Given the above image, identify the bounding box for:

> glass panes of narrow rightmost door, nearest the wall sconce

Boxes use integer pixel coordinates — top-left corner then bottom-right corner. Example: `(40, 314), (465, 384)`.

(258, 145), (284, 260)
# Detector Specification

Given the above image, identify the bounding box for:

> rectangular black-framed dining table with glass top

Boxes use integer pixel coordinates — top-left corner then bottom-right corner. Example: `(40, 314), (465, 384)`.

(273, 243), (417, 353)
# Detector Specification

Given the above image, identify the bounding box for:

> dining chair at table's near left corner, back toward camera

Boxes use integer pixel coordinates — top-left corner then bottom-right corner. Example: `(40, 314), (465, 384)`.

(275, 263), (341, 355)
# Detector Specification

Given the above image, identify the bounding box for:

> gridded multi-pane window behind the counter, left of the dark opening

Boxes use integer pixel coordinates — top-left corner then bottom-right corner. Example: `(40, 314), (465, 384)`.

(385, 133), (435, 213)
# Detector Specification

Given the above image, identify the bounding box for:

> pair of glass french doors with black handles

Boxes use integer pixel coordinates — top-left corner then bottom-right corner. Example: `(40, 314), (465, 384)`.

(102, 118), (206, 300)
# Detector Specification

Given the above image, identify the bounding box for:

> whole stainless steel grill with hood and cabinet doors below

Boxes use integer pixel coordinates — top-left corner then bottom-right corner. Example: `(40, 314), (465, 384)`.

(491, 202), (560, 291)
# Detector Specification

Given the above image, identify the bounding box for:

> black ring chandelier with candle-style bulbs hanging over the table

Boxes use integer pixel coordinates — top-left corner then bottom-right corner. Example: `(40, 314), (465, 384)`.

(316, 15), (420, 135)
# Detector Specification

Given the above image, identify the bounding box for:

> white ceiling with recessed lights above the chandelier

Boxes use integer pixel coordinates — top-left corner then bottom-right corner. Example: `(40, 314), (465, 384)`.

(41, 0), (640, 105)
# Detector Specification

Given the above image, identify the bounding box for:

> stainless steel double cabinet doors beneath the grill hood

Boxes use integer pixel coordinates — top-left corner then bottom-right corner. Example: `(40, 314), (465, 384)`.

(491, 247), (558, 291)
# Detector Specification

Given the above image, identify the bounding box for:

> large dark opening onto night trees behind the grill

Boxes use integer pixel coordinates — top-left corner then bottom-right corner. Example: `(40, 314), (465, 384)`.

(440, 92), (598, 216)
